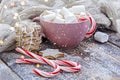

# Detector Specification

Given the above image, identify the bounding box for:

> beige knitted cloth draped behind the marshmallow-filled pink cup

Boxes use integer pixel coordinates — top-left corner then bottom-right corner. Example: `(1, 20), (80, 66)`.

(1, 0), (111, 28)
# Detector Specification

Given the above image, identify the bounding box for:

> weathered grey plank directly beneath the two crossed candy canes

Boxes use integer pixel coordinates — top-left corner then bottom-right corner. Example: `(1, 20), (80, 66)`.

(0, 53), (116, 80)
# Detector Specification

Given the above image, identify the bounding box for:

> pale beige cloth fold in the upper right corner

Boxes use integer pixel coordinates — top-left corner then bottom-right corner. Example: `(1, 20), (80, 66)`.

(98, 0), (120, 33)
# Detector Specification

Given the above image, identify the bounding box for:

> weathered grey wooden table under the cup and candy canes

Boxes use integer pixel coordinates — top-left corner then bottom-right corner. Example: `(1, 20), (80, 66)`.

(0, 33), (120, 80)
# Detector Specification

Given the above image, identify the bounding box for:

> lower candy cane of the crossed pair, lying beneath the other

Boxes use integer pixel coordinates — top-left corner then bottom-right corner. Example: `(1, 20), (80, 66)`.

(16, 59), (81, 72)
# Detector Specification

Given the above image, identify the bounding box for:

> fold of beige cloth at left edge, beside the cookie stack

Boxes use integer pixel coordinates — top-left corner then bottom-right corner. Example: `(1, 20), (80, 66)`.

(0, 24), (15, 52)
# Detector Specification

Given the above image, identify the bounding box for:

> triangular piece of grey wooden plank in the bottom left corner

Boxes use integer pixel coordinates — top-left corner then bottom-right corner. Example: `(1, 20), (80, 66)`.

(0, 60), (22, 80)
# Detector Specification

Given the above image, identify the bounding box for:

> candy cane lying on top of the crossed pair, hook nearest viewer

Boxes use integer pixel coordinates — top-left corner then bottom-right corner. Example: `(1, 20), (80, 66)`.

(16, 48), (60, 77)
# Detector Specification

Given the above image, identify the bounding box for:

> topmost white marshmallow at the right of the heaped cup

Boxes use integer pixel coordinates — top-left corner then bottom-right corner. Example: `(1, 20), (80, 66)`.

(69, 5), (86, 14)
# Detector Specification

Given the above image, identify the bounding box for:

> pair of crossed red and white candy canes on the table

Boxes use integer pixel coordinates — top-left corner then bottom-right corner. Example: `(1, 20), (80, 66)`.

(16, 48), (81, 77)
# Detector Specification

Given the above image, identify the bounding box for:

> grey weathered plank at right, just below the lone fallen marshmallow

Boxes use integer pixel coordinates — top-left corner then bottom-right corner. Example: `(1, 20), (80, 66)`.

(79, 41), (120, 75)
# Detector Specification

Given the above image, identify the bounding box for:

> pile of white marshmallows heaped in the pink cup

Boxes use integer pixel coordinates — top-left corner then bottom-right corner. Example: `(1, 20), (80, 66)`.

(41, 5), (87, 23)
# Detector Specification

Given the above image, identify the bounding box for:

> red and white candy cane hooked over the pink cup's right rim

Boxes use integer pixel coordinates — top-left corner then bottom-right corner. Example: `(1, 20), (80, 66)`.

(78, 14), (97, 38)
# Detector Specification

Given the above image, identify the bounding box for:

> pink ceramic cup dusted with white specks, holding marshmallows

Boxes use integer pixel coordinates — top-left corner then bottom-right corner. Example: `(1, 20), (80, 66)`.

(34, 17), (90, 48)
